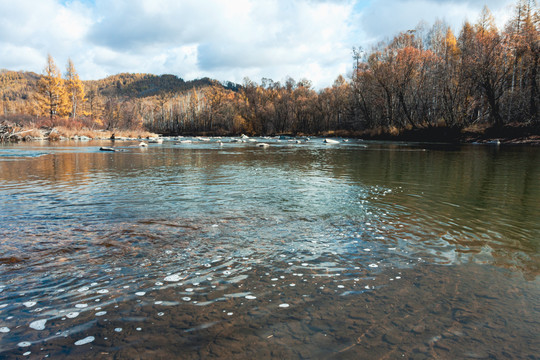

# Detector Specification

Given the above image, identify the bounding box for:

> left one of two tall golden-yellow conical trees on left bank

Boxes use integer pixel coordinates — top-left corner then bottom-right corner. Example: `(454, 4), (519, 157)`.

(38, 54), (69, 120)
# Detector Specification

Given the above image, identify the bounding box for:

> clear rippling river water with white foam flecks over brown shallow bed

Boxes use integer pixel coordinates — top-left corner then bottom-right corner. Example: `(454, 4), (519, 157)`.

(0, 139), (540, 358)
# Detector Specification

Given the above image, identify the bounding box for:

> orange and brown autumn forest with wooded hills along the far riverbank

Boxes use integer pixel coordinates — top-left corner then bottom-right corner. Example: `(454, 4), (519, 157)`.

(0, 0), (540, 141)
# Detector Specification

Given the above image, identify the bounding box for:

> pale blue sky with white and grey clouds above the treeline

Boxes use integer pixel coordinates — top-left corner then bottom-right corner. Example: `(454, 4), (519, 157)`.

(0, 0), (515, 88)
